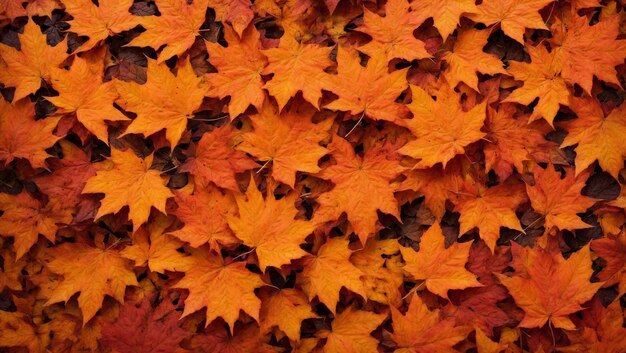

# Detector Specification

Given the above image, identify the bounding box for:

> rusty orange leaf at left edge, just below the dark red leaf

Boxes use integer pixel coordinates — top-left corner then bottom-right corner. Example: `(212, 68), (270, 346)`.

(0, 192), (72, 260)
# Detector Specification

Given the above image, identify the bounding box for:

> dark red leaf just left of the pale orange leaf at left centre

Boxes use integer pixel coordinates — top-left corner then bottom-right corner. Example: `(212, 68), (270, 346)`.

(35, 140), (96, 207)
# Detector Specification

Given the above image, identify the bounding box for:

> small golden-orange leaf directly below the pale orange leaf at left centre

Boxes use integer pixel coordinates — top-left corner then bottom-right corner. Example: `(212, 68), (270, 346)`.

(120, 215), (192, 273)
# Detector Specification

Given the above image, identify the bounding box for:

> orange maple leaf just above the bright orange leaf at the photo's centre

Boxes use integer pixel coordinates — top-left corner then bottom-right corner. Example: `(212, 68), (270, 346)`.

(237, 103), (333, 188)
